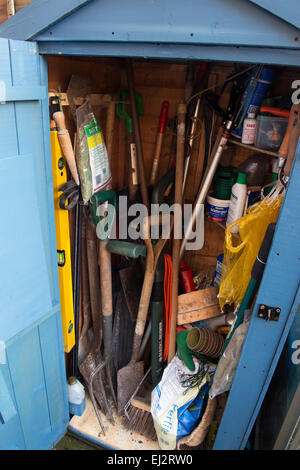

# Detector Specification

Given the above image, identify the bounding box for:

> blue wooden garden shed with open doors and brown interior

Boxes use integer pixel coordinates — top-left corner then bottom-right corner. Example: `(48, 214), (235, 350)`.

(0, 0), (300, 450)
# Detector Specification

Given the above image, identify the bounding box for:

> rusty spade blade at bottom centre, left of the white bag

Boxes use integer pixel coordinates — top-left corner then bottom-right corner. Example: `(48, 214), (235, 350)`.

(118, 361), (144, 415)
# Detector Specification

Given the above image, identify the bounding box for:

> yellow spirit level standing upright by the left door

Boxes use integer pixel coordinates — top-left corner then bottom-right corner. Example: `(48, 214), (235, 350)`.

(50, 112), (75, 353)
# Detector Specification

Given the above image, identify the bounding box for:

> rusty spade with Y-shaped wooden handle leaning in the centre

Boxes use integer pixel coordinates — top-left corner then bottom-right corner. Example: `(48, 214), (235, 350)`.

(118, 216), (173, 414)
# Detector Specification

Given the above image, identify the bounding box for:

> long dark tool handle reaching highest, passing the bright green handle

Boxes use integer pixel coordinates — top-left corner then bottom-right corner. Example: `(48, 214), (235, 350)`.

(126, 59), (149, 209)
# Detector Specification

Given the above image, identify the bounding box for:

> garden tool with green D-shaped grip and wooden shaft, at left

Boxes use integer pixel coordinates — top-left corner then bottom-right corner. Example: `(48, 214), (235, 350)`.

(89, 189), (117, 405)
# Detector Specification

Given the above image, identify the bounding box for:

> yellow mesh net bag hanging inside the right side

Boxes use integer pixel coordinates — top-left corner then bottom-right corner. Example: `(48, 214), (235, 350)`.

(219, 191), (284, 308)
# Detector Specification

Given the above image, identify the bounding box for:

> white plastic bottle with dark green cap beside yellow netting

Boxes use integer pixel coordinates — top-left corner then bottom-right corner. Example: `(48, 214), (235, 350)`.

(226, 171), (247, 233)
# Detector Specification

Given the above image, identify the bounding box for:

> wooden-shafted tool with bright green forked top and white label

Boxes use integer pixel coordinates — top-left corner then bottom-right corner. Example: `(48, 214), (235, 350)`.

(116, 90), (144, 201)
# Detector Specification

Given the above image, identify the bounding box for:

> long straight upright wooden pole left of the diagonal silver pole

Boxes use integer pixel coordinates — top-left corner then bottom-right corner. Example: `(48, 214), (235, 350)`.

(168, 104), (186, 363)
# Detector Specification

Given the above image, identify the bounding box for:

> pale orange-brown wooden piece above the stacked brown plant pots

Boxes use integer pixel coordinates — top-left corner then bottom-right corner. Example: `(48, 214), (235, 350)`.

(177, 287), (220, 325)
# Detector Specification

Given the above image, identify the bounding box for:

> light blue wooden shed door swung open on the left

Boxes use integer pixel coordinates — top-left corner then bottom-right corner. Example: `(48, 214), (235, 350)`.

(0, 39), (69, 449)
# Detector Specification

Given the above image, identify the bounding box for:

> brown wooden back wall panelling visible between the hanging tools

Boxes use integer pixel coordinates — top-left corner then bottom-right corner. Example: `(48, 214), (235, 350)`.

(48, 56), (297, 273)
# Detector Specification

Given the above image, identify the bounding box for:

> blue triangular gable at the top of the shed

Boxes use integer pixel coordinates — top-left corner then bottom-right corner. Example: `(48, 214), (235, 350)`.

(0, 0), (300, 50)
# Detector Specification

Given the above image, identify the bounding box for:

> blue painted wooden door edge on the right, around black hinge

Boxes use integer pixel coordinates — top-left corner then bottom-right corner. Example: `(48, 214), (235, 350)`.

(214, 142), (300, 450)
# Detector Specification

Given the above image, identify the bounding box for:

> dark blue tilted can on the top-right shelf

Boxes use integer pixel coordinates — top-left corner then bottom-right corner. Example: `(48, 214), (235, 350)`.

(232, 66), (275, 139)
